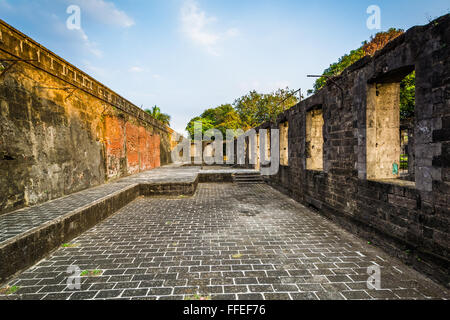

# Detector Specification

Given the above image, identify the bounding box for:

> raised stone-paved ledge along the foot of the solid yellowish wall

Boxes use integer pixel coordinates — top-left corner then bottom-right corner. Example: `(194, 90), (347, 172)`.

(0, 165), (255, 283)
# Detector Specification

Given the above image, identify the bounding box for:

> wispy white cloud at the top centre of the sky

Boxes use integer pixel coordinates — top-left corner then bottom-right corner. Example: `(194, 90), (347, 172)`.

(181, 0), (239, 55)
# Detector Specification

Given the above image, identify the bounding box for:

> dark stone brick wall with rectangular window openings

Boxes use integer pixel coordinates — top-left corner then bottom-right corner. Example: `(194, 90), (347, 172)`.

(253, 15), (450, 285)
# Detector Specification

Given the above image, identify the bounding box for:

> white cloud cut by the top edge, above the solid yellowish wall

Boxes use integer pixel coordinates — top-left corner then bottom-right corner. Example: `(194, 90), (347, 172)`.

(69, 0), (135, 28)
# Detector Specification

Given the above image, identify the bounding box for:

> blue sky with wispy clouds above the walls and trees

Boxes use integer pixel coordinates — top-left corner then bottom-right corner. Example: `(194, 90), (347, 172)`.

(0, 0), (450, 132)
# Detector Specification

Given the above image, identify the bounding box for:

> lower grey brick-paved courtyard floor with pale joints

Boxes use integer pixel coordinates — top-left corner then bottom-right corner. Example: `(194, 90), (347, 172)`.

(3, 183), (450, 300)
